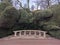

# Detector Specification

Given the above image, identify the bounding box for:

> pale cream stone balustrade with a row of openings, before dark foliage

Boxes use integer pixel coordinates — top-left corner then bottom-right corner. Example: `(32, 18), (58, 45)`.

(13, 30), (46, 38)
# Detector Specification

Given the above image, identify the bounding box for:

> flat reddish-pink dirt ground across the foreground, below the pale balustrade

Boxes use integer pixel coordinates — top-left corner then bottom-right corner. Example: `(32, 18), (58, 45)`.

(0, 39), (60, 45)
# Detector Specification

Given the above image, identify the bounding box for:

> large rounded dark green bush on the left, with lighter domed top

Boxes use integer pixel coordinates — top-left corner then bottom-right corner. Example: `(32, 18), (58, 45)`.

(0, 6), (19, 28)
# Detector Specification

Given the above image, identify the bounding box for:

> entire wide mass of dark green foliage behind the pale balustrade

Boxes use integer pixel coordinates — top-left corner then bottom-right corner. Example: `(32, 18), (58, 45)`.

(0, 3), (60, 39)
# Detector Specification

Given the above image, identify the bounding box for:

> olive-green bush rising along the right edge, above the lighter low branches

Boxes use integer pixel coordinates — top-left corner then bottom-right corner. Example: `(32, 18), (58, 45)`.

(51, 5), (60, 26)
